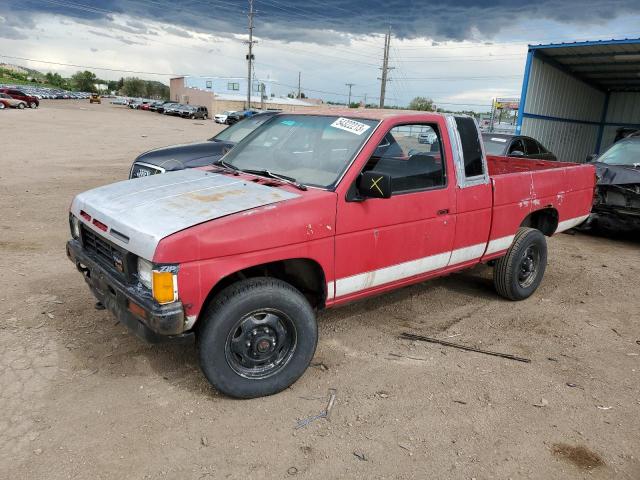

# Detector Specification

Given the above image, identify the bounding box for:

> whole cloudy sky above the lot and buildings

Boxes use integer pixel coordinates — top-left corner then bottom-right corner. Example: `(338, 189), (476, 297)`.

(0, 0), (640, 111)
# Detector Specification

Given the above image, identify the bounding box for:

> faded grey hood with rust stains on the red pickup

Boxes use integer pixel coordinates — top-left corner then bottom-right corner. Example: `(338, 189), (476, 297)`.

(71, 170), (299, 260)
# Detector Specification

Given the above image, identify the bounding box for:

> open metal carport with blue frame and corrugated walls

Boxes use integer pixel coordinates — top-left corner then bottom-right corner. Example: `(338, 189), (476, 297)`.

(516, 39), (640, 162)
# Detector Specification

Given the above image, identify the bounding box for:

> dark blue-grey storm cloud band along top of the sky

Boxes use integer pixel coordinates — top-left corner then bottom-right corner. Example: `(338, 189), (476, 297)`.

(0, 0), (640, 44)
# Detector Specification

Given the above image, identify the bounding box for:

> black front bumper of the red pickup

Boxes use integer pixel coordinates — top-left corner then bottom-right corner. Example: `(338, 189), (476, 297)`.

(67, 240), (194, 343)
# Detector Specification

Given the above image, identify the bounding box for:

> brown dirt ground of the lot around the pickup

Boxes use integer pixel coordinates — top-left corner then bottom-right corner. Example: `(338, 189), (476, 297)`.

(0, 101), (640, 480)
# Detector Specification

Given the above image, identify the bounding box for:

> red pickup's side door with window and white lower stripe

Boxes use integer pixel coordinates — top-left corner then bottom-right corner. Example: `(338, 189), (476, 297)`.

(335, 123), (455, 301)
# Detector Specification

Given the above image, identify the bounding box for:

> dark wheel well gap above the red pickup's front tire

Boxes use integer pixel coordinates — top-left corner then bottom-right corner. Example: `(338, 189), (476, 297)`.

(202, 258), (327, 311)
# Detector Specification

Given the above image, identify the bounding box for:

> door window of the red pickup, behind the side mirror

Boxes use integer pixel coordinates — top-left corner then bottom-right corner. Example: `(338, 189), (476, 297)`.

(363, 124), (446, 194)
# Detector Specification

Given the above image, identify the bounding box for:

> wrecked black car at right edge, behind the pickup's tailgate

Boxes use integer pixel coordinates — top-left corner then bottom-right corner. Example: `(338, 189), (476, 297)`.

(585, 132), (640, 232)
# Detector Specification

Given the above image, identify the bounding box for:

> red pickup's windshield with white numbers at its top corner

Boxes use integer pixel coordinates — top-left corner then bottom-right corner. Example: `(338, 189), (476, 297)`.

(224, 115), (378, 188)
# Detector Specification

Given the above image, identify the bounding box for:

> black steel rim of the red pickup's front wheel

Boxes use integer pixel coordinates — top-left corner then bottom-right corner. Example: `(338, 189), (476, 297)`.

(224, 309), (297, 379)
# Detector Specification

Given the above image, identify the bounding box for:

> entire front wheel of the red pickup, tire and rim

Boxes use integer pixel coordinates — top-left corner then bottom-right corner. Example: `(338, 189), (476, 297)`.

(198, 277), (318, 398)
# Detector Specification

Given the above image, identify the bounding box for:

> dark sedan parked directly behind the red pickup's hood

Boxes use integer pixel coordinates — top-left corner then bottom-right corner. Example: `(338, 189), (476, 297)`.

(129, 112), (275, 178)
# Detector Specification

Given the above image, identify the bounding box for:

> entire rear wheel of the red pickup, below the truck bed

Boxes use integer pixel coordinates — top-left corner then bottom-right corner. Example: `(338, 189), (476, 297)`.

(493, 228), (547, 300)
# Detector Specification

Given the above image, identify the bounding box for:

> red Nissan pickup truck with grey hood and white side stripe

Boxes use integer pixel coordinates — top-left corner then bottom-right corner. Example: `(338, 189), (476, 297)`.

(67, 110), (596, 398)
